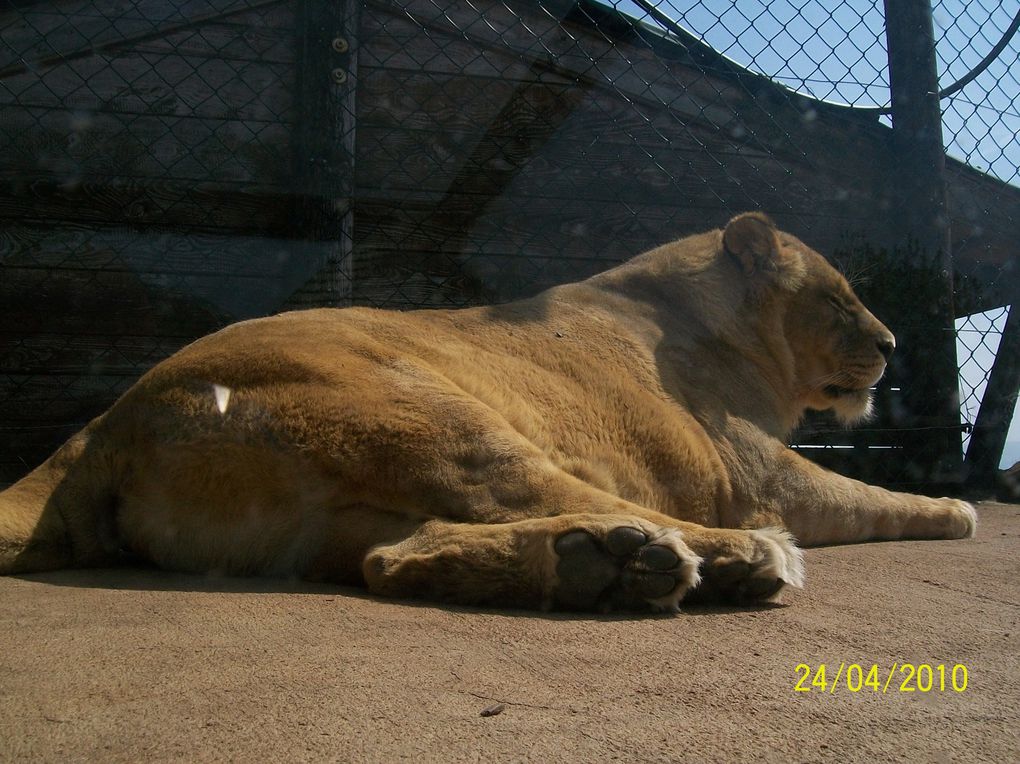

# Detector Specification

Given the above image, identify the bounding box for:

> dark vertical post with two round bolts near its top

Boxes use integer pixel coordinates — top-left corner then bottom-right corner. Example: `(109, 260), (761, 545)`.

(288, 0), (361, 308)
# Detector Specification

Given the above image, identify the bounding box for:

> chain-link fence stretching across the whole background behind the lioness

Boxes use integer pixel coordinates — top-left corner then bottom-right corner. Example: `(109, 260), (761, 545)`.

(0, 0), (1020, 487)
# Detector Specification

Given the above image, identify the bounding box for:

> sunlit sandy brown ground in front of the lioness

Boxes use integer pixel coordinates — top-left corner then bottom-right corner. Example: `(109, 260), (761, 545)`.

(0, 504), (1020, 762)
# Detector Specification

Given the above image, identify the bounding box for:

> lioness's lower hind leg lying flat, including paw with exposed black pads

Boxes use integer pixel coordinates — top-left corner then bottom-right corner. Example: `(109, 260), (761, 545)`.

(363, 514), (701, 612)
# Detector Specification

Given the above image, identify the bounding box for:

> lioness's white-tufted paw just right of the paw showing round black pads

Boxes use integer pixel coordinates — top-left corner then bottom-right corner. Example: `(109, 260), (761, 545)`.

(687, 528), (804, 604)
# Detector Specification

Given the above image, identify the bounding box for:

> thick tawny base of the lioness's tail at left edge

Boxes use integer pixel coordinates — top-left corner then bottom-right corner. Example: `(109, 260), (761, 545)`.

(0, 420), (114, 575)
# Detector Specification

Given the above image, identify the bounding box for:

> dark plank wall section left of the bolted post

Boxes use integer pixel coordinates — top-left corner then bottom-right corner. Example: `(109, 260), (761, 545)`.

(0, 0), (316, 481)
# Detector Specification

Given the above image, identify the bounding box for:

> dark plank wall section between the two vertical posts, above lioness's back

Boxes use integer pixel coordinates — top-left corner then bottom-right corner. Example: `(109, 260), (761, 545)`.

(355, 0), (901, 305)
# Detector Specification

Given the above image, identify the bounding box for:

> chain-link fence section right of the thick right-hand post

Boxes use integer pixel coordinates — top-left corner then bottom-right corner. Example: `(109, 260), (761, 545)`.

(932, 0), (1020, 489)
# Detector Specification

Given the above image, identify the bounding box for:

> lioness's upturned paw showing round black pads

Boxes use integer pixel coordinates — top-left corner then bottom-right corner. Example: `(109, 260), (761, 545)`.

(554, 524), (701, 612)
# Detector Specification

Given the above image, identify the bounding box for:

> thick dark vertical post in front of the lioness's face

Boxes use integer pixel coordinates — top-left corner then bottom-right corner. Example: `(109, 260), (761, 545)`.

(884, 0), (963, 489)
